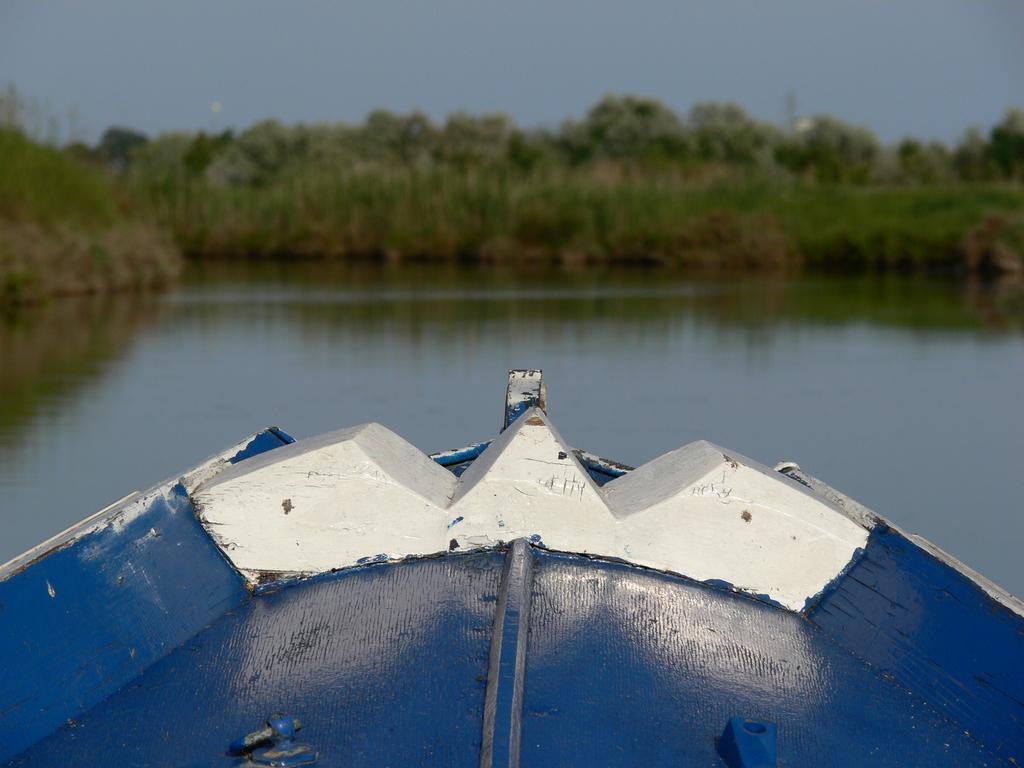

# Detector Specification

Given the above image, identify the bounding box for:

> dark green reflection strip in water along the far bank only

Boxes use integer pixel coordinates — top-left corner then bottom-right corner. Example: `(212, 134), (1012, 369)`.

(178, 263), (1024, 334)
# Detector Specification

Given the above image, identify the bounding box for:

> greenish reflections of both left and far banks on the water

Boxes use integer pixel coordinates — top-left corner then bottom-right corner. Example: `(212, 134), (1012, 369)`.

(0, 263), (1024, 441)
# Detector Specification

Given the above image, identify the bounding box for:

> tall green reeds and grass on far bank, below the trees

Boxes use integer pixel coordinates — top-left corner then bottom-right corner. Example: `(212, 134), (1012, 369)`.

(148, 169), (1024, 271)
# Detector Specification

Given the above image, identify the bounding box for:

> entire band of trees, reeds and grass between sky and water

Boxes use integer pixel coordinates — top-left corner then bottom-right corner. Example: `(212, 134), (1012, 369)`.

(6, 96), (1024, 303)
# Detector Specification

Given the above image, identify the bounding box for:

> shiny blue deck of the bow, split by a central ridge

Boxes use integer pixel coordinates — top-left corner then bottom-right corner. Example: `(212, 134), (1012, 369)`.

(9, 550), (1021, 766)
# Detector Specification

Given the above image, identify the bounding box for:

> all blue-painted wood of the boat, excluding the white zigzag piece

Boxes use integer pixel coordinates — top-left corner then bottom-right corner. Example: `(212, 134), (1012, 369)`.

(0, 376), (1024, 766)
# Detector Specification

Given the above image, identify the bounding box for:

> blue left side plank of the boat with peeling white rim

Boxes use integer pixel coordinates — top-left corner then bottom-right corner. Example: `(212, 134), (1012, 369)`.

(0, 429), (291, 762)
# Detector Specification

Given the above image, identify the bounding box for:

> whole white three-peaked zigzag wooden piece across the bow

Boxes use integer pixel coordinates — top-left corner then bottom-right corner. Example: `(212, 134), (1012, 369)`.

(193, 408), (867, 610)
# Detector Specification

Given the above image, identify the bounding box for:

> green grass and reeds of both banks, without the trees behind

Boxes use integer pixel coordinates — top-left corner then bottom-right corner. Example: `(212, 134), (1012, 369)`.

(0, 121), (1024, 304)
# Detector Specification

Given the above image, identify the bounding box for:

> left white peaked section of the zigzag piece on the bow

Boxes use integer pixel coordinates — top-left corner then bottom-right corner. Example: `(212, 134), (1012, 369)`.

(193, 424), (456, 581)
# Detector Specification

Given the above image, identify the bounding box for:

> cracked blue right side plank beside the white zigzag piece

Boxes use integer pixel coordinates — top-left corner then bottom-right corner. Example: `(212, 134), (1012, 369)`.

(809, 525), (1024, 764)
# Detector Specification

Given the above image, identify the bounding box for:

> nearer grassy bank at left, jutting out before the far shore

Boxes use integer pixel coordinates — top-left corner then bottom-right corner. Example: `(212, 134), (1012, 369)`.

(0, 128), (182, 305)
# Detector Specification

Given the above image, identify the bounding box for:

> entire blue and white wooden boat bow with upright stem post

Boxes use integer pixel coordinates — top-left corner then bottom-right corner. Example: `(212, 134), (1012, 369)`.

(0, 371), (1024, 767)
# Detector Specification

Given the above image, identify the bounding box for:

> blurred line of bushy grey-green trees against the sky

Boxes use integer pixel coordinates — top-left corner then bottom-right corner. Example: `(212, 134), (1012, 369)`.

(77, 95), (1024, 187)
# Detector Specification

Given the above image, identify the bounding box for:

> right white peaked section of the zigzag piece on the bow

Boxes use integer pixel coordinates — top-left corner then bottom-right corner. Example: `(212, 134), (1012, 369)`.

(605, 441), (867, 609)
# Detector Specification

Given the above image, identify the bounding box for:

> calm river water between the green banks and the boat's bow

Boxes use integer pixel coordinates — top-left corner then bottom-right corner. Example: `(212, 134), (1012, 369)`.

(0, 264), (1024, 595)
